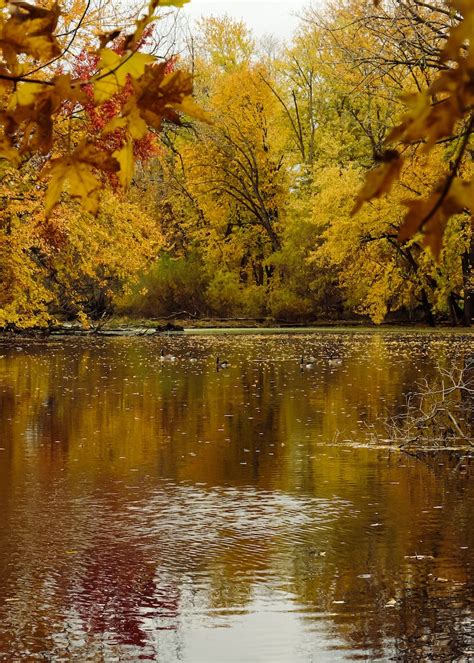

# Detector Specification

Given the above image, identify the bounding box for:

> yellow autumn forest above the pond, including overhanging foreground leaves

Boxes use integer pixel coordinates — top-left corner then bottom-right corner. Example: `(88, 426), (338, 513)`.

(0, 0), (474, 329)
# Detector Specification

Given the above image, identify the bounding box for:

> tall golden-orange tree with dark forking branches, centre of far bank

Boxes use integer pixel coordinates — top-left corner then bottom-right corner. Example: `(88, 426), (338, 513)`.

(152, 19), (287, 300)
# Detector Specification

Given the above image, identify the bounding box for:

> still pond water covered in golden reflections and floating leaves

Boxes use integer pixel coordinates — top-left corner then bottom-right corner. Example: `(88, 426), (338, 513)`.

(0, 332), (474, 663)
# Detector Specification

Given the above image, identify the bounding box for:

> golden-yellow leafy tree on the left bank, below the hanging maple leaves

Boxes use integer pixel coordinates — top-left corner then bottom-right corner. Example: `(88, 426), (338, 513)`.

(0, 164), (162, 328)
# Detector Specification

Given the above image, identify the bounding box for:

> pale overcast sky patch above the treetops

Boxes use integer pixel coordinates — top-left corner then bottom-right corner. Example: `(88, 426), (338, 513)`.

(183, 0), (311, 39)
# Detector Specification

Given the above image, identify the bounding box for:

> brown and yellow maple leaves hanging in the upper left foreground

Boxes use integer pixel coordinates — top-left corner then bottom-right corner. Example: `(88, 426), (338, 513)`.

(0, 0), (205, 215)
